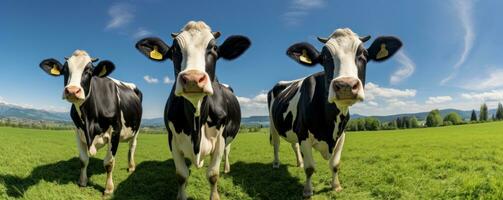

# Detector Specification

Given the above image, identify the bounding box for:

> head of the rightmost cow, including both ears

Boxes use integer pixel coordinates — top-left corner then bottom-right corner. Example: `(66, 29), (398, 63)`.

(287, 28), (402, 107)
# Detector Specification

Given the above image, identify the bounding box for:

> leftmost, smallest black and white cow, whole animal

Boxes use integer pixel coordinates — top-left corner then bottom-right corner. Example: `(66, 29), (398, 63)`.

(40, 50), (142, 195)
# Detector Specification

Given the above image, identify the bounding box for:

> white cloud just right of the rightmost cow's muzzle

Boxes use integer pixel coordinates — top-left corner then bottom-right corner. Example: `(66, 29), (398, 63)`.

(365, 82), (416, 100)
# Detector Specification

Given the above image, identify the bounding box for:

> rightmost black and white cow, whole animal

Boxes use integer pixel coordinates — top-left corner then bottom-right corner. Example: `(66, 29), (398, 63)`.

(268, 28), (402, 197)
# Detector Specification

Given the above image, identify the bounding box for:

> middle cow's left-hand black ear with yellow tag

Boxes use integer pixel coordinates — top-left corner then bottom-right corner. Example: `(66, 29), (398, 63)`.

(135, 37), (171, 61)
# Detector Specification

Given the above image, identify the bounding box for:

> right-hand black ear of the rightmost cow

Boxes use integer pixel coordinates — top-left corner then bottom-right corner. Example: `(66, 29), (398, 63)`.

(367, 36), (402, 62)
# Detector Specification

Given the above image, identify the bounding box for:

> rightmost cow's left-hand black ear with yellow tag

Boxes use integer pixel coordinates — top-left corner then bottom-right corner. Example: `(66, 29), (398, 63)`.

(286, 42), (320, 67)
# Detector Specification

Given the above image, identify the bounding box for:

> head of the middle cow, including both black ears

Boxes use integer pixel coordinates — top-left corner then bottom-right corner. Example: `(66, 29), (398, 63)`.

(136, 21), (251, 105)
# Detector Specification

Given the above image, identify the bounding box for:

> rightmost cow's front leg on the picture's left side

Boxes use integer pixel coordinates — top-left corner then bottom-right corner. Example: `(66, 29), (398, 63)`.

(300, 140), (315, 198)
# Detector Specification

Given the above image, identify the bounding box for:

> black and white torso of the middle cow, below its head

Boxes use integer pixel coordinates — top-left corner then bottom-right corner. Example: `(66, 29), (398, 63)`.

(164, 81), (241, 169)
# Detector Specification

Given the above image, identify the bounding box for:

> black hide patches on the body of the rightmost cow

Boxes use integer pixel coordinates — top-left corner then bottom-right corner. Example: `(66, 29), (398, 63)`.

(269, 72), (349, 153)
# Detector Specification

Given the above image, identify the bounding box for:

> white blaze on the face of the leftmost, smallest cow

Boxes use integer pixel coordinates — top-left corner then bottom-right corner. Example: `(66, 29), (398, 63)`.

(63, 50), (91, 100)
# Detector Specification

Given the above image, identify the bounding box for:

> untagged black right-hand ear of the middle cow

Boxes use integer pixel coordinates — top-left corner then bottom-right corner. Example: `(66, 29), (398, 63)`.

(218, 35), (251, 60)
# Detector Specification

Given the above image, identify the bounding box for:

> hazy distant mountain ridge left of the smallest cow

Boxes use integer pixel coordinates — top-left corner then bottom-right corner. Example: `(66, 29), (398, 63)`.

(0, 103), (70, 122)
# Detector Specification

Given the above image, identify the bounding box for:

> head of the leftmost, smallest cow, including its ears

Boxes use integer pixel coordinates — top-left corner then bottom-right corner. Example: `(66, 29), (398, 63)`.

(40, 50), (115, 105)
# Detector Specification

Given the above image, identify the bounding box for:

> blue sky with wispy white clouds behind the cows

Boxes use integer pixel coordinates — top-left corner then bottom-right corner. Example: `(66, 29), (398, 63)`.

(0, 0), (503, 118)
